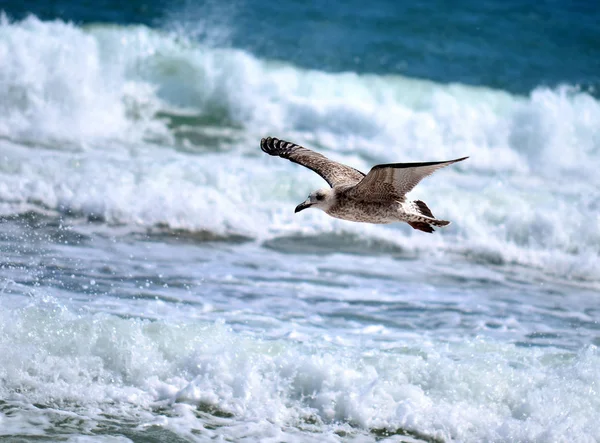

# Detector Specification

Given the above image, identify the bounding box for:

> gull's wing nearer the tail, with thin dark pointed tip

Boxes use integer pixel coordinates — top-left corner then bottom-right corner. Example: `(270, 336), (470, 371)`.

(351, 157), (469, 201)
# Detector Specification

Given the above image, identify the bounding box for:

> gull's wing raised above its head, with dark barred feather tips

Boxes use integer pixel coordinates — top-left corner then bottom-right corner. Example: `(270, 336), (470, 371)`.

(260, 137), (365, 188)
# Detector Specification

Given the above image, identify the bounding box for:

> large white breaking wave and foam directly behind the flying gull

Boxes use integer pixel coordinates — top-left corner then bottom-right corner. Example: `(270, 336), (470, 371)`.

(0, 17), (600, 281)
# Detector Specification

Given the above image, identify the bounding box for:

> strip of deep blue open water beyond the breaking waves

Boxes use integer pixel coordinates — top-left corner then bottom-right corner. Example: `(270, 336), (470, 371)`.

(0, 0), (600, 95)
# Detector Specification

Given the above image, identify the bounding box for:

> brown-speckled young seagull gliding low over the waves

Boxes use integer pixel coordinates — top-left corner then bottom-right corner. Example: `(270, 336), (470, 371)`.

(260, 137), (469, 233)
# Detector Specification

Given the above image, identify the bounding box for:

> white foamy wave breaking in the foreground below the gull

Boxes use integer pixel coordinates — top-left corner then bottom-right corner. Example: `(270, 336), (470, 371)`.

(0, 297), (600, 442)
